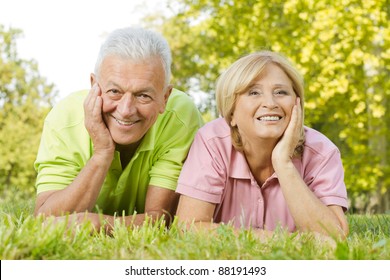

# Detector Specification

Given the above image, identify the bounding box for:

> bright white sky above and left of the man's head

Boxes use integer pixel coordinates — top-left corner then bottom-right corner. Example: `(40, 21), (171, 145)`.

(0, 0), (165, 103)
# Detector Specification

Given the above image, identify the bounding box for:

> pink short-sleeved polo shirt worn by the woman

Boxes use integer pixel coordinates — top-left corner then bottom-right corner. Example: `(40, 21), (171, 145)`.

(176, 118), (348, 232)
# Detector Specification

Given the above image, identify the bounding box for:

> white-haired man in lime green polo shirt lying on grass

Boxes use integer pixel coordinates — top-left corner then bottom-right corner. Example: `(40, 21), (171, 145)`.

(35, 28), (202, 231)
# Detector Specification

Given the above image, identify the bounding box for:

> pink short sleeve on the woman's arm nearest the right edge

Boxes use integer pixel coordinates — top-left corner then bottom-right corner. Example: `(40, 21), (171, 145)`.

(306, 148), (348, 211)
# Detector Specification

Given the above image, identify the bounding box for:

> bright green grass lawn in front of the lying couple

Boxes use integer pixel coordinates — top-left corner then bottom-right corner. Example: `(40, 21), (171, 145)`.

(0, 189), (390, 260)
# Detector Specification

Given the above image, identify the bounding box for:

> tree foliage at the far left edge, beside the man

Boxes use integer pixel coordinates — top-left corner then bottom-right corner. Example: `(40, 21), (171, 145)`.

(0, 25), (54, 194)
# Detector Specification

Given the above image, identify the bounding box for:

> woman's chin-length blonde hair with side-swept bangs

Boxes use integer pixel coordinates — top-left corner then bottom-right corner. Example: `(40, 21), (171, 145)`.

(216, 51), (305, 156)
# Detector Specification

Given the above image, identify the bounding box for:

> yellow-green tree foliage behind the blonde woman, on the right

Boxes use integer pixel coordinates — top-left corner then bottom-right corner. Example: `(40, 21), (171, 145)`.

(145, 0), (390, 211)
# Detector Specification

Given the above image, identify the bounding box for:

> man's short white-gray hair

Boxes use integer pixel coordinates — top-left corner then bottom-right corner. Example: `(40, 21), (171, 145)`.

(95, 27), (172, 86)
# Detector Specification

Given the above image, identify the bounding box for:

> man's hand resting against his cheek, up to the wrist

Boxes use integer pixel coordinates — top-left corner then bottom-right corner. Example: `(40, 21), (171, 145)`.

(84, 83), (115, 160)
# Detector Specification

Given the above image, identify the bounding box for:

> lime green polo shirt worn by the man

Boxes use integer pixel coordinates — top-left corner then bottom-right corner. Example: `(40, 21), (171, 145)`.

(34, 89), (203, 215)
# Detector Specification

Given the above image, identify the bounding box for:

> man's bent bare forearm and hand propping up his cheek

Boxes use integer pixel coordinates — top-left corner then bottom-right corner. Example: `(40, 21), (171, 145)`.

(34, 86), (115, 215)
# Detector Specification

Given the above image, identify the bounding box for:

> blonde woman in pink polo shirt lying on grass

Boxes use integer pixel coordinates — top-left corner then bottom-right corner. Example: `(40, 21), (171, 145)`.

(176, 51), (348, 238)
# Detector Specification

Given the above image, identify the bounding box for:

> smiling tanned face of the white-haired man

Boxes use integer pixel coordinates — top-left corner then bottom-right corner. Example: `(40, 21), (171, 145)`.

(96, 56), (171, 146)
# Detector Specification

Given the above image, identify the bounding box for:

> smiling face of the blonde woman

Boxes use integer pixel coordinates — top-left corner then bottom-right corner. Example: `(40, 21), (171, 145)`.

(231, 63), (296, 145)
